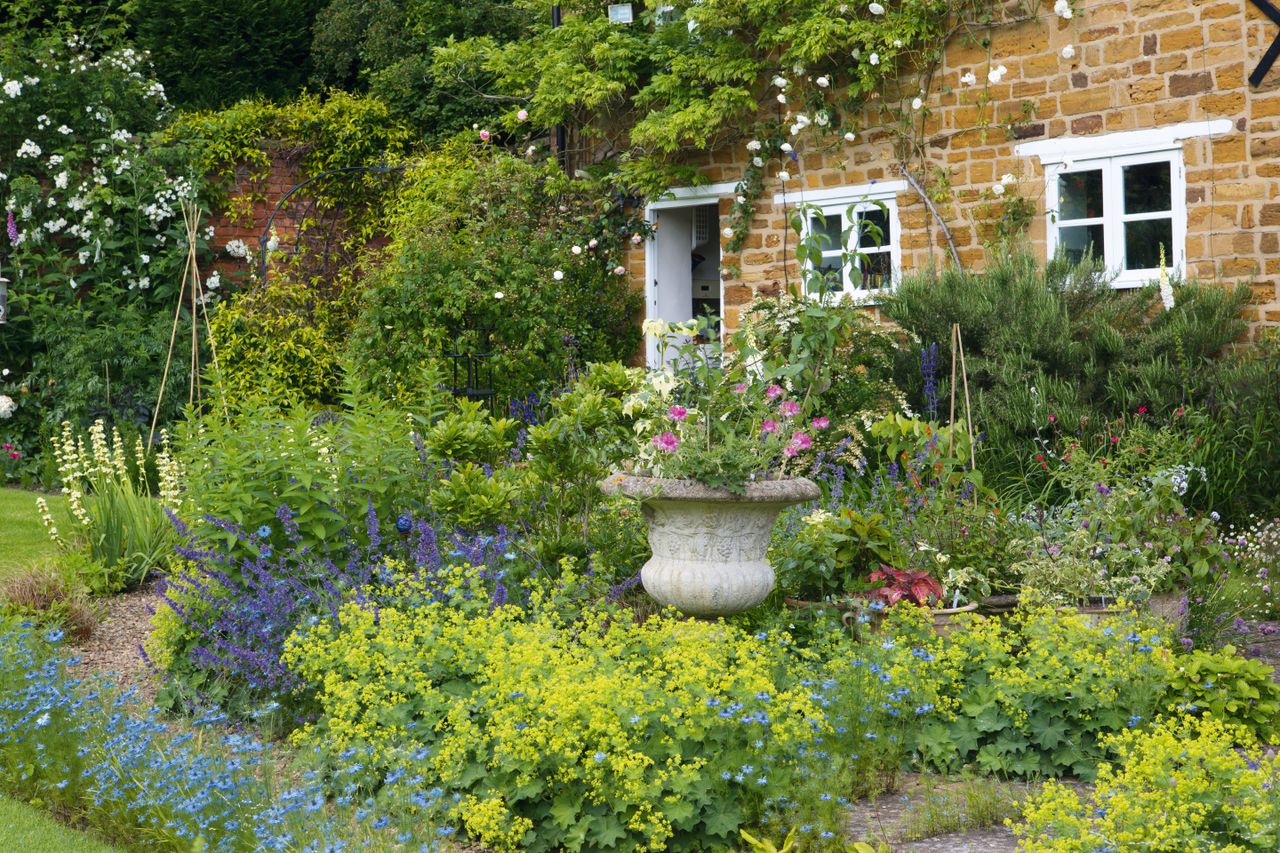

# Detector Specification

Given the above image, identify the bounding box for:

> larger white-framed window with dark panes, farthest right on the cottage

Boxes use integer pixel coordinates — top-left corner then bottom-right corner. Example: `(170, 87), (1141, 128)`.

(1015, 119), (1231, 287)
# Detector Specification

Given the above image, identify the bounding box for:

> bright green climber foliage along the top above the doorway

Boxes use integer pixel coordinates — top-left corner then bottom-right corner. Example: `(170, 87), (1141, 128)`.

(436, 0), (988, 192)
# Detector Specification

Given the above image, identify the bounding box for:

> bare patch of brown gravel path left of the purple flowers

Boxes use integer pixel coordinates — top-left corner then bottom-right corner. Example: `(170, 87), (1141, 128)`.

(68, 580), (160, 706)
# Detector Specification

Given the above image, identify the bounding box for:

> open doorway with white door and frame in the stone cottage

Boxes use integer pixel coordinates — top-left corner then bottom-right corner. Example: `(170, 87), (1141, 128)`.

(645, 197), (721, 364)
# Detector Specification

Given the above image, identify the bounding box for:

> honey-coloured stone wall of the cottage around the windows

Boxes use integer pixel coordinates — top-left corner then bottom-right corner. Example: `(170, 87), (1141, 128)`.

(628, 0), (1280, 333)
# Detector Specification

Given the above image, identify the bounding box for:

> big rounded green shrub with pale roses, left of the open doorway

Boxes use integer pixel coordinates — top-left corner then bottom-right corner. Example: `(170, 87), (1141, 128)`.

(351, 141), (641, 402)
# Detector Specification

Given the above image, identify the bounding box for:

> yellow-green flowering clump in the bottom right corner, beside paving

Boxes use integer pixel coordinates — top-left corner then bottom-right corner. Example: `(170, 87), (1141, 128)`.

(1015, 716), (1280, 853)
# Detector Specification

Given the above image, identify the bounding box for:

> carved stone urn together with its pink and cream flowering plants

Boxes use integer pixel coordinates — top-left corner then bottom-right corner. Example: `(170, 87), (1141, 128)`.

(602, 319), (826, 616)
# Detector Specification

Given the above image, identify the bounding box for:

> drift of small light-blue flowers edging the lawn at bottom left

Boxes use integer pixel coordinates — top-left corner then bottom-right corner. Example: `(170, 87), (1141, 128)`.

(0, 622), (456, 853)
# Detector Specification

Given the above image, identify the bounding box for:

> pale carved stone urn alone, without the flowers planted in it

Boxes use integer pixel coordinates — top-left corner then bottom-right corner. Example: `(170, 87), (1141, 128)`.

(600, 474), (822, 616)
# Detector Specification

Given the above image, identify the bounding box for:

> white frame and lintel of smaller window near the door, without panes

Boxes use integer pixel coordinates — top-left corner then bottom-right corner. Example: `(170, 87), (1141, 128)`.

(773, 181), (908, 298)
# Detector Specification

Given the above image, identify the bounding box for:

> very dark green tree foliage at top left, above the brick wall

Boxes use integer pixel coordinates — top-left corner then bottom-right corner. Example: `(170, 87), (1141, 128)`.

(132, 0), (324, 108)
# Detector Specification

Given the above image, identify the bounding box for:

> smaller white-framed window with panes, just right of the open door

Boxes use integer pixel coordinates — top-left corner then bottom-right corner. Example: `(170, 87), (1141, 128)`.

(774, 181), (906, 302)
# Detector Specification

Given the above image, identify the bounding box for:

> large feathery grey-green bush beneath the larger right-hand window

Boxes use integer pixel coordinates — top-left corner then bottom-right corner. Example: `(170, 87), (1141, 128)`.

(884, 245), (1259, 511)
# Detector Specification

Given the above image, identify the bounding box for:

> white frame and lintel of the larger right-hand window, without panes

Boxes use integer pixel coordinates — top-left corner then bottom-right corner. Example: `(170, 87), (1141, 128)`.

(1015, 119), (1233, 288)
